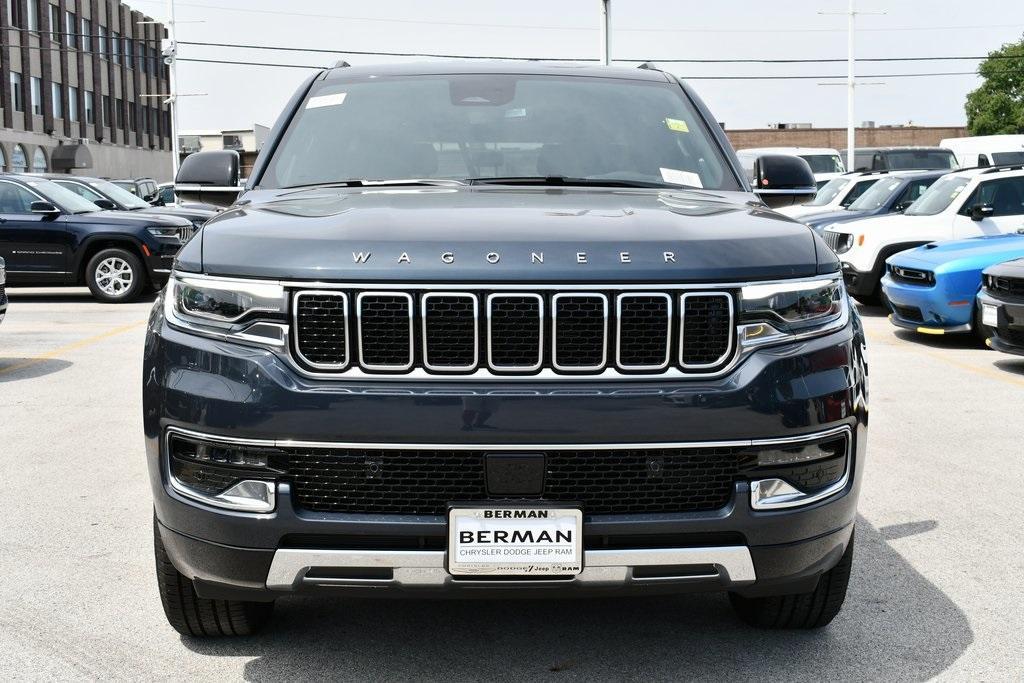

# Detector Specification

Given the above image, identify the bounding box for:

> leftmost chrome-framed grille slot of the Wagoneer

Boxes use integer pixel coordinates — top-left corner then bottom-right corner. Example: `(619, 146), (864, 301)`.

(294, 291), (348, 370)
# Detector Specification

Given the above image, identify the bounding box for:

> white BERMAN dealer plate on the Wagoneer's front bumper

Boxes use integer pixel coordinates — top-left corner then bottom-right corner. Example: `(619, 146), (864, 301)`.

(447, 507), (583, 577)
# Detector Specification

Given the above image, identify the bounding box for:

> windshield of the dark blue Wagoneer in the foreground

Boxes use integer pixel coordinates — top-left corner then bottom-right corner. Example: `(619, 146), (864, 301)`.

(259, 74), (740, 189)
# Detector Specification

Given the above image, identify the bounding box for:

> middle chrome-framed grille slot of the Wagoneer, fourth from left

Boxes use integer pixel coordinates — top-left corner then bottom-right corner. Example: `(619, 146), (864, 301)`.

(487, 294), (544, 372)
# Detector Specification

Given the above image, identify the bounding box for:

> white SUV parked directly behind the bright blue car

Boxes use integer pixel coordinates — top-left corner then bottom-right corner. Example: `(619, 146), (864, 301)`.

(822, 165), (1024, 303)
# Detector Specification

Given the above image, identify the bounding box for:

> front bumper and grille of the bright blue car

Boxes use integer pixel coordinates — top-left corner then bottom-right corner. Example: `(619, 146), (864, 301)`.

(882, 273), (974, 335)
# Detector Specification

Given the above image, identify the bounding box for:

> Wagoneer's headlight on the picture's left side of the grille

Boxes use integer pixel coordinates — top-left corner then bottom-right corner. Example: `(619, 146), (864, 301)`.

(164, 274), (288, 345)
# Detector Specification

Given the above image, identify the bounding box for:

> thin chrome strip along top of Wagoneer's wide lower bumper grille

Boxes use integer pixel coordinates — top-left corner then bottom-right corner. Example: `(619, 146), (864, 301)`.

(167, 424), (853, 453)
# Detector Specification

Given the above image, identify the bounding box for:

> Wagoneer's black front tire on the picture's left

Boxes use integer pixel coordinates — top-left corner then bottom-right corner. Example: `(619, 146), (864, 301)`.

(153, 518), (273, 638)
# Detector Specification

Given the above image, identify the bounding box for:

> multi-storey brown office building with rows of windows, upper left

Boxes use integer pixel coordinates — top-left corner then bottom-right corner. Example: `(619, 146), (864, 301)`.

(0, 0), (171, 180)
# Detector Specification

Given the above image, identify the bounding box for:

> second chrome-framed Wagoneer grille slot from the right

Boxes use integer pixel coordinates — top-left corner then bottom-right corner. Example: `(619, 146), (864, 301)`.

(615, 292), (672, 370)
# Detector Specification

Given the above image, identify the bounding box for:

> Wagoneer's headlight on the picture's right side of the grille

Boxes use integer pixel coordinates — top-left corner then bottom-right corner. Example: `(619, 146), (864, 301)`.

(740, 274), (849, 343)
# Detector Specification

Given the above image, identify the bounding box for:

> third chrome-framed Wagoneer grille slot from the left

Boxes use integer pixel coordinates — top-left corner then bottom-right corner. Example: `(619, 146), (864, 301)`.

(422, 293), (479, 371)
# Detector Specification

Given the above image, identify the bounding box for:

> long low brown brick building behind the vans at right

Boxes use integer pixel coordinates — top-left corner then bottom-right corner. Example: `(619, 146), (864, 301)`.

(725, 126), (968, 150)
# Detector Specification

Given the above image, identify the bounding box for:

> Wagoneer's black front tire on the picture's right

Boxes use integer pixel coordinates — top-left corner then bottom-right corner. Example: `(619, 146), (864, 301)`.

(729, 536), (853, 630)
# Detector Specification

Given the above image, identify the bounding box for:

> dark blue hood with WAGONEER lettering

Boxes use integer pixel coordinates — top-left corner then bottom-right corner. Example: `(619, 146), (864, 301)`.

(184, 186), (823, 283)
